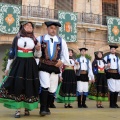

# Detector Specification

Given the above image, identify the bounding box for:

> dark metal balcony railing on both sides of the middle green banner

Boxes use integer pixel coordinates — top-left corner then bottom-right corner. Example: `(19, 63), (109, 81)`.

(21, 6), (106, 25)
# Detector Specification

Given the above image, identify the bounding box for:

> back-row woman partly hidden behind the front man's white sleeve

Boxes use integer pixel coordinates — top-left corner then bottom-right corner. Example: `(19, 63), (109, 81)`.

(57, 49), (77, 108)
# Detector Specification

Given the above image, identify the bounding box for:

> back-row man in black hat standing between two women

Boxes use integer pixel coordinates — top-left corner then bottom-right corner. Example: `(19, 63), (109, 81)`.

(76, 48), (94, 108)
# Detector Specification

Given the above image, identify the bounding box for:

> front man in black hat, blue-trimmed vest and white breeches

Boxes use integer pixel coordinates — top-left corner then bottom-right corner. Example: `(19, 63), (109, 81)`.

(37, 21), (69, 116)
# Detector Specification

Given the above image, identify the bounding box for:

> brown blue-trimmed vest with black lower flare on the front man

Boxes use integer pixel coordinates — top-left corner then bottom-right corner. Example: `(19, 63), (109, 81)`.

(39, 36), (62, 74)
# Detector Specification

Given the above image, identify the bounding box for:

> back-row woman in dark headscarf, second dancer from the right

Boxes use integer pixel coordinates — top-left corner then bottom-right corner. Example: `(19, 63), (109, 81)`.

(88, 51), (108, 108)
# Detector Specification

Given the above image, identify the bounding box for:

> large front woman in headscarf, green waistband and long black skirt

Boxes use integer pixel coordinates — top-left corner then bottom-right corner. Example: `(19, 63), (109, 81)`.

(0, 22), (40, 118)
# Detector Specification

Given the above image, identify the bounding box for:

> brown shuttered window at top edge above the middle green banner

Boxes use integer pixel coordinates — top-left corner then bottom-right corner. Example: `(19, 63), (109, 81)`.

(55, 0), (73, 11)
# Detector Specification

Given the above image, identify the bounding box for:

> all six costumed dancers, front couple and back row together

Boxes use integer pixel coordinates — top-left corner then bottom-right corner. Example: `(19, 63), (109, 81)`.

(0, 21), (120, 118)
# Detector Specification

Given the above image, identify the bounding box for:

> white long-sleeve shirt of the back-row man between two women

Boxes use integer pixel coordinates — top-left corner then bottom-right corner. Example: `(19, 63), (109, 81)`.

(76, 56), (94, 80)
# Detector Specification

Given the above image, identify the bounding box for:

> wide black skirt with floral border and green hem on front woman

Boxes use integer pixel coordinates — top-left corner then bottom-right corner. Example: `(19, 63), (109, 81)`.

(0, 57), (40, 110)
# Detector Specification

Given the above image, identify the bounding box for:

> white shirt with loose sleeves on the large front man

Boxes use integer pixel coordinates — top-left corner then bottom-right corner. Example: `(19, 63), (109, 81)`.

(37, 34), (70, 64)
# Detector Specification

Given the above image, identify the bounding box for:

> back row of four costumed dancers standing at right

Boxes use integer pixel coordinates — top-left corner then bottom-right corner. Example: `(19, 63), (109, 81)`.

(56, 45), (120, 108)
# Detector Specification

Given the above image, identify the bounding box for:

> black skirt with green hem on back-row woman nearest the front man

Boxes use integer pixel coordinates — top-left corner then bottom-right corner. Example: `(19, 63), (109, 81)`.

(56, 70), (77, 103)
